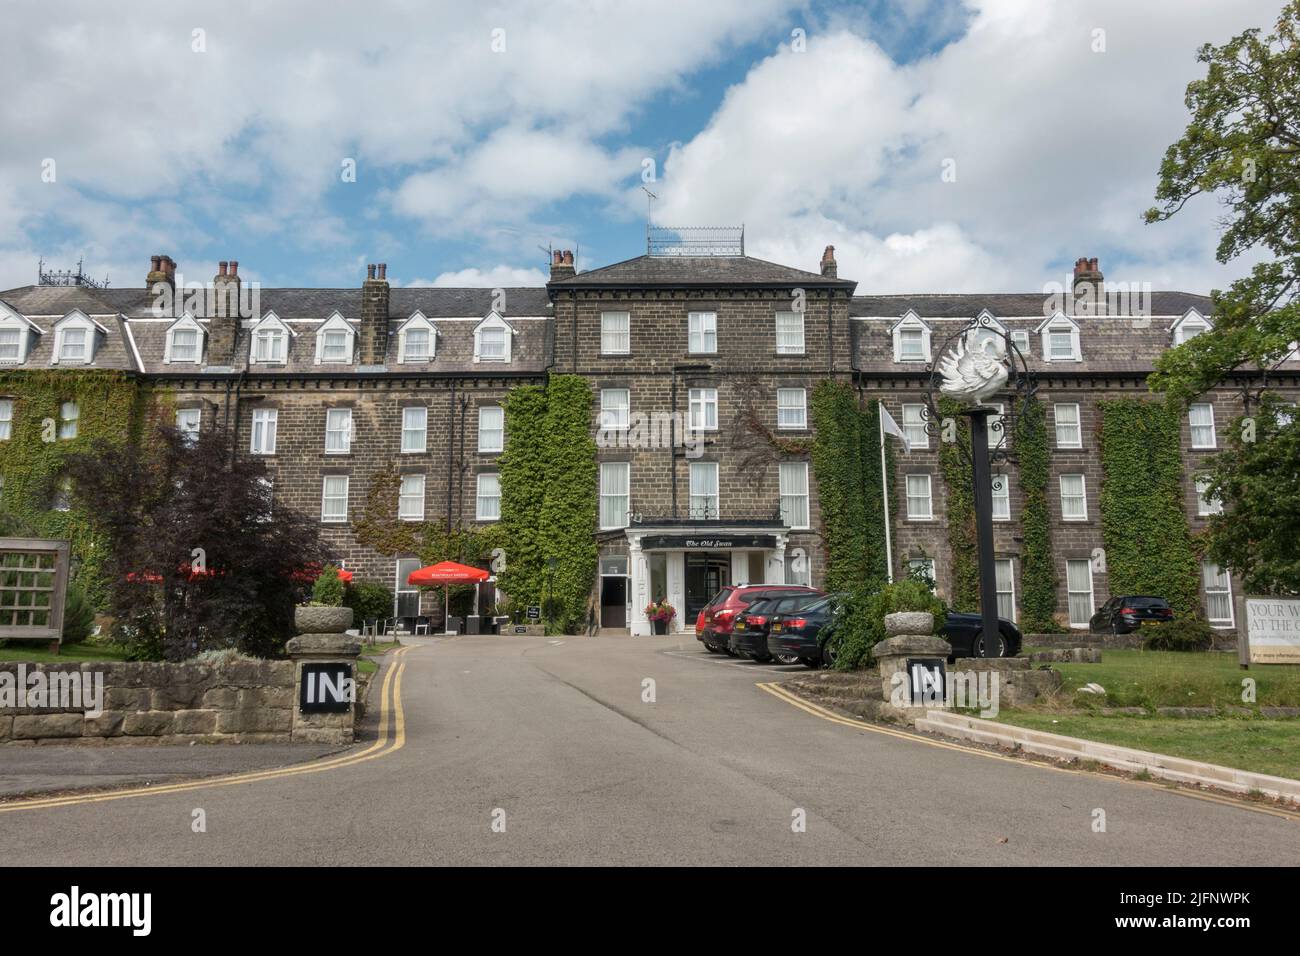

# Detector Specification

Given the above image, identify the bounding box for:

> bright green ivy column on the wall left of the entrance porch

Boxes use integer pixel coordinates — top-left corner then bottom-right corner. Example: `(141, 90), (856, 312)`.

(501, 375), (598, 633)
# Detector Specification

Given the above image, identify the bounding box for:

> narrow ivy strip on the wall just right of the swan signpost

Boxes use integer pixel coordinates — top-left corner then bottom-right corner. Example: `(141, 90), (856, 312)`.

(1015, 398), (1063, 633)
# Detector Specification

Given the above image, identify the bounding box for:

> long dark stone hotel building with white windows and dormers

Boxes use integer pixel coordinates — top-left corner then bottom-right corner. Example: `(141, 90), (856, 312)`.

(0, 240), (1300, 633)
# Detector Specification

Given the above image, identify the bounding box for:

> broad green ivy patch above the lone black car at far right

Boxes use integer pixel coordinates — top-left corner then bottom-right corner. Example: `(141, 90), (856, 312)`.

(1097, 398), (1200, 615)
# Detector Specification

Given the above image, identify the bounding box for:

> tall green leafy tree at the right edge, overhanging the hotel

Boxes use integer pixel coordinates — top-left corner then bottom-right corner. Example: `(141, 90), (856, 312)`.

(1145, 0), (1300, 592)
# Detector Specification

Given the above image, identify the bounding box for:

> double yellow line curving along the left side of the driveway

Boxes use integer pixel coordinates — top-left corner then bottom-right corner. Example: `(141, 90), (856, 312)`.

(0, 645), (416, 813)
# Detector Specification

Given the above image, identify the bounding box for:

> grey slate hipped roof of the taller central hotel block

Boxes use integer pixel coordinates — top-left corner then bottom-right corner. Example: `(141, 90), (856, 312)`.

(549, 256), (858, 289)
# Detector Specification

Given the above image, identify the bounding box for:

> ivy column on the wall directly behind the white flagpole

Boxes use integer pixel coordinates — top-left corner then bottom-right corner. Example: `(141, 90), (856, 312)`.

(811, 380), (892, 591)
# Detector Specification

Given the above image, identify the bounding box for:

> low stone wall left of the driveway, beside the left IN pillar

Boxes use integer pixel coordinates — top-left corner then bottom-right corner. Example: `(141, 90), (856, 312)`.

(0, 661), (295, 745)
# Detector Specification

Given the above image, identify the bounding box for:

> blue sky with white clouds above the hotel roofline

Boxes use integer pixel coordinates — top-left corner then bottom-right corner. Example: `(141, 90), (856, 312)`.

(0, 0), (1281, 293)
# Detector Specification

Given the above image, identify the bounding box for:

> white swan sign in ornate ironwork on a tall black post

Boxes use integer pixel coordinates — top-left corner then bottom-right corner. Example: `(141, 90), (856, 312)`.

(926, 312), (1037, 657)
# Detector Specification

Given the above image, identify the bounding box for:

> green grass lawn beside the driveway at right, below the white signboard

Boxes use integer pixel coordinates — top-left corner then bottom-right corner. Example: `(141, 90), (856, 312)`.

(997, 649), (1300, 779)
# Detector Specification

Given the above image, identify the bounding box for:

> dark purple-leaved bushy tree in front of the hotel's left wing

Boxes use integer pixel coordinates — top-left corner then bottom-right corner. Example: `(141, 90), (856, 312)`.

(66, 427), (329, 661)
